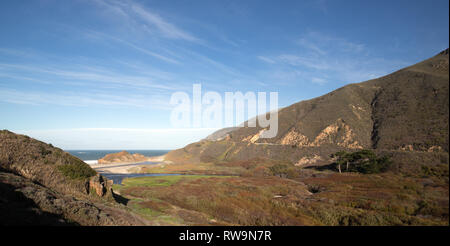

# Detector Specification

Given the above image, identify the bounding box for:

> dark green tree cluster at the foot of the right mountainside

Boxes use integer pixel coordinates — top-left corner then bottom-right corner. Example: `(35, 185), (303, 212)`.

(330, 150), (391, 174)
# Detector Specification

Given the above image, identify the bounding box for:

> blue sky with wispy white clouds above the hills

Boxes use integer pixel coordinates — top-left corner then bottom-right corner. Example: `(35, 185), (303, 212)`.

(0, 0), (449, 149)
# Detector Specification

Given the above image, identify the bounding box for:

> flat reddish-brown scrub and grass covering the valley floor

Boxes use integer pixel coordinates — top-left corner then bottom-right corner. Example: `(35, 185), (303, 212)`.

(114, 169), (448, 225)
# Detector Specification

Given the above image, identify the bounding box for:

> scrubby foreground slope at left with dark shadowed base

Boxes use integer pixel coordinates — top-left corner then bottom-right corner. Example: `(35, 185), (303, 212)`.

(0, 130), (147, 225)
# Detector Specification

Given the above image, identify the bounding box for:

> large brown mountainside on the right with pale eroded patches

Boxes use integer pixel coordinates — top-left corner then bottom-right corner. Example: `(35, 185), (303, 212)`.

(166, 49), (449, 169)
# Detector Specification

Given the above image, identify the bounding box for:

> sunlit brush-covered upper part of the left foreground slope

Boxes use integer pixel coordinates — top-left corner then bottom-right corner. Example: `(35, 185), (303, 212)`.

(0, 130), (96, 195)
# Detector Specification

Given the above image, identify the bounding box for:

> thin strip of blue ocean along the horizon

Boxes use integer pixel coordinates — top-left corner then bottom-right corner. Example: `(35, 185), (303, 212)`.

(65, 150), (170, 161)
